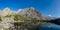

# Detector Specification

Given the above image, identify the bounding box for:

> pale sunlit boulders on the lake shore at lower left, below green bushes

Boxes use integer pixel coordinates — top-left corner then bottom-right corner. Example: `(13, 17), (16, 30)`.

(1, 17), (14, 28)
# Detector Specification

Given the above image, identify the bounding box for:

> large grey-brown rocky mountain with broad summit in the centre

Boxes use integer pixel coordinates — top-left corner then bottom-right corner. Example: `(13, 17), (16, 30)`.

(18, 7), (46, 20)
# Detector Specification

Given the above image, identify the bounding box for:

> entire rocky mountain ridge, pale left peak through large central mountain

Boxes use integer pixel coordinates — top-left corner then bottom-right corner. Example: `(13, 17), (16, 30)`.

(0, 7), (51, 20)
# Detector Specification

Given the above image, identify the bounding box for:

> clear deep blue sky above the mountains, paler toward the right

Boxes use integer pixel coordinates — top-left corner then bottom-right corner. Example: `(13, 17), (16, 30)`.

(0, 0), (60, 17)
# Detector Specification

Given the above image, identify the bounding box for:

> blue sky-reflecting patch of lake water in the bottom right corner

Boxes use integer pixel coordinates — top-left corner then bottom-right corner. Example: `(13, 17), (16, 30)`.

(39, 24), (60, 30)
